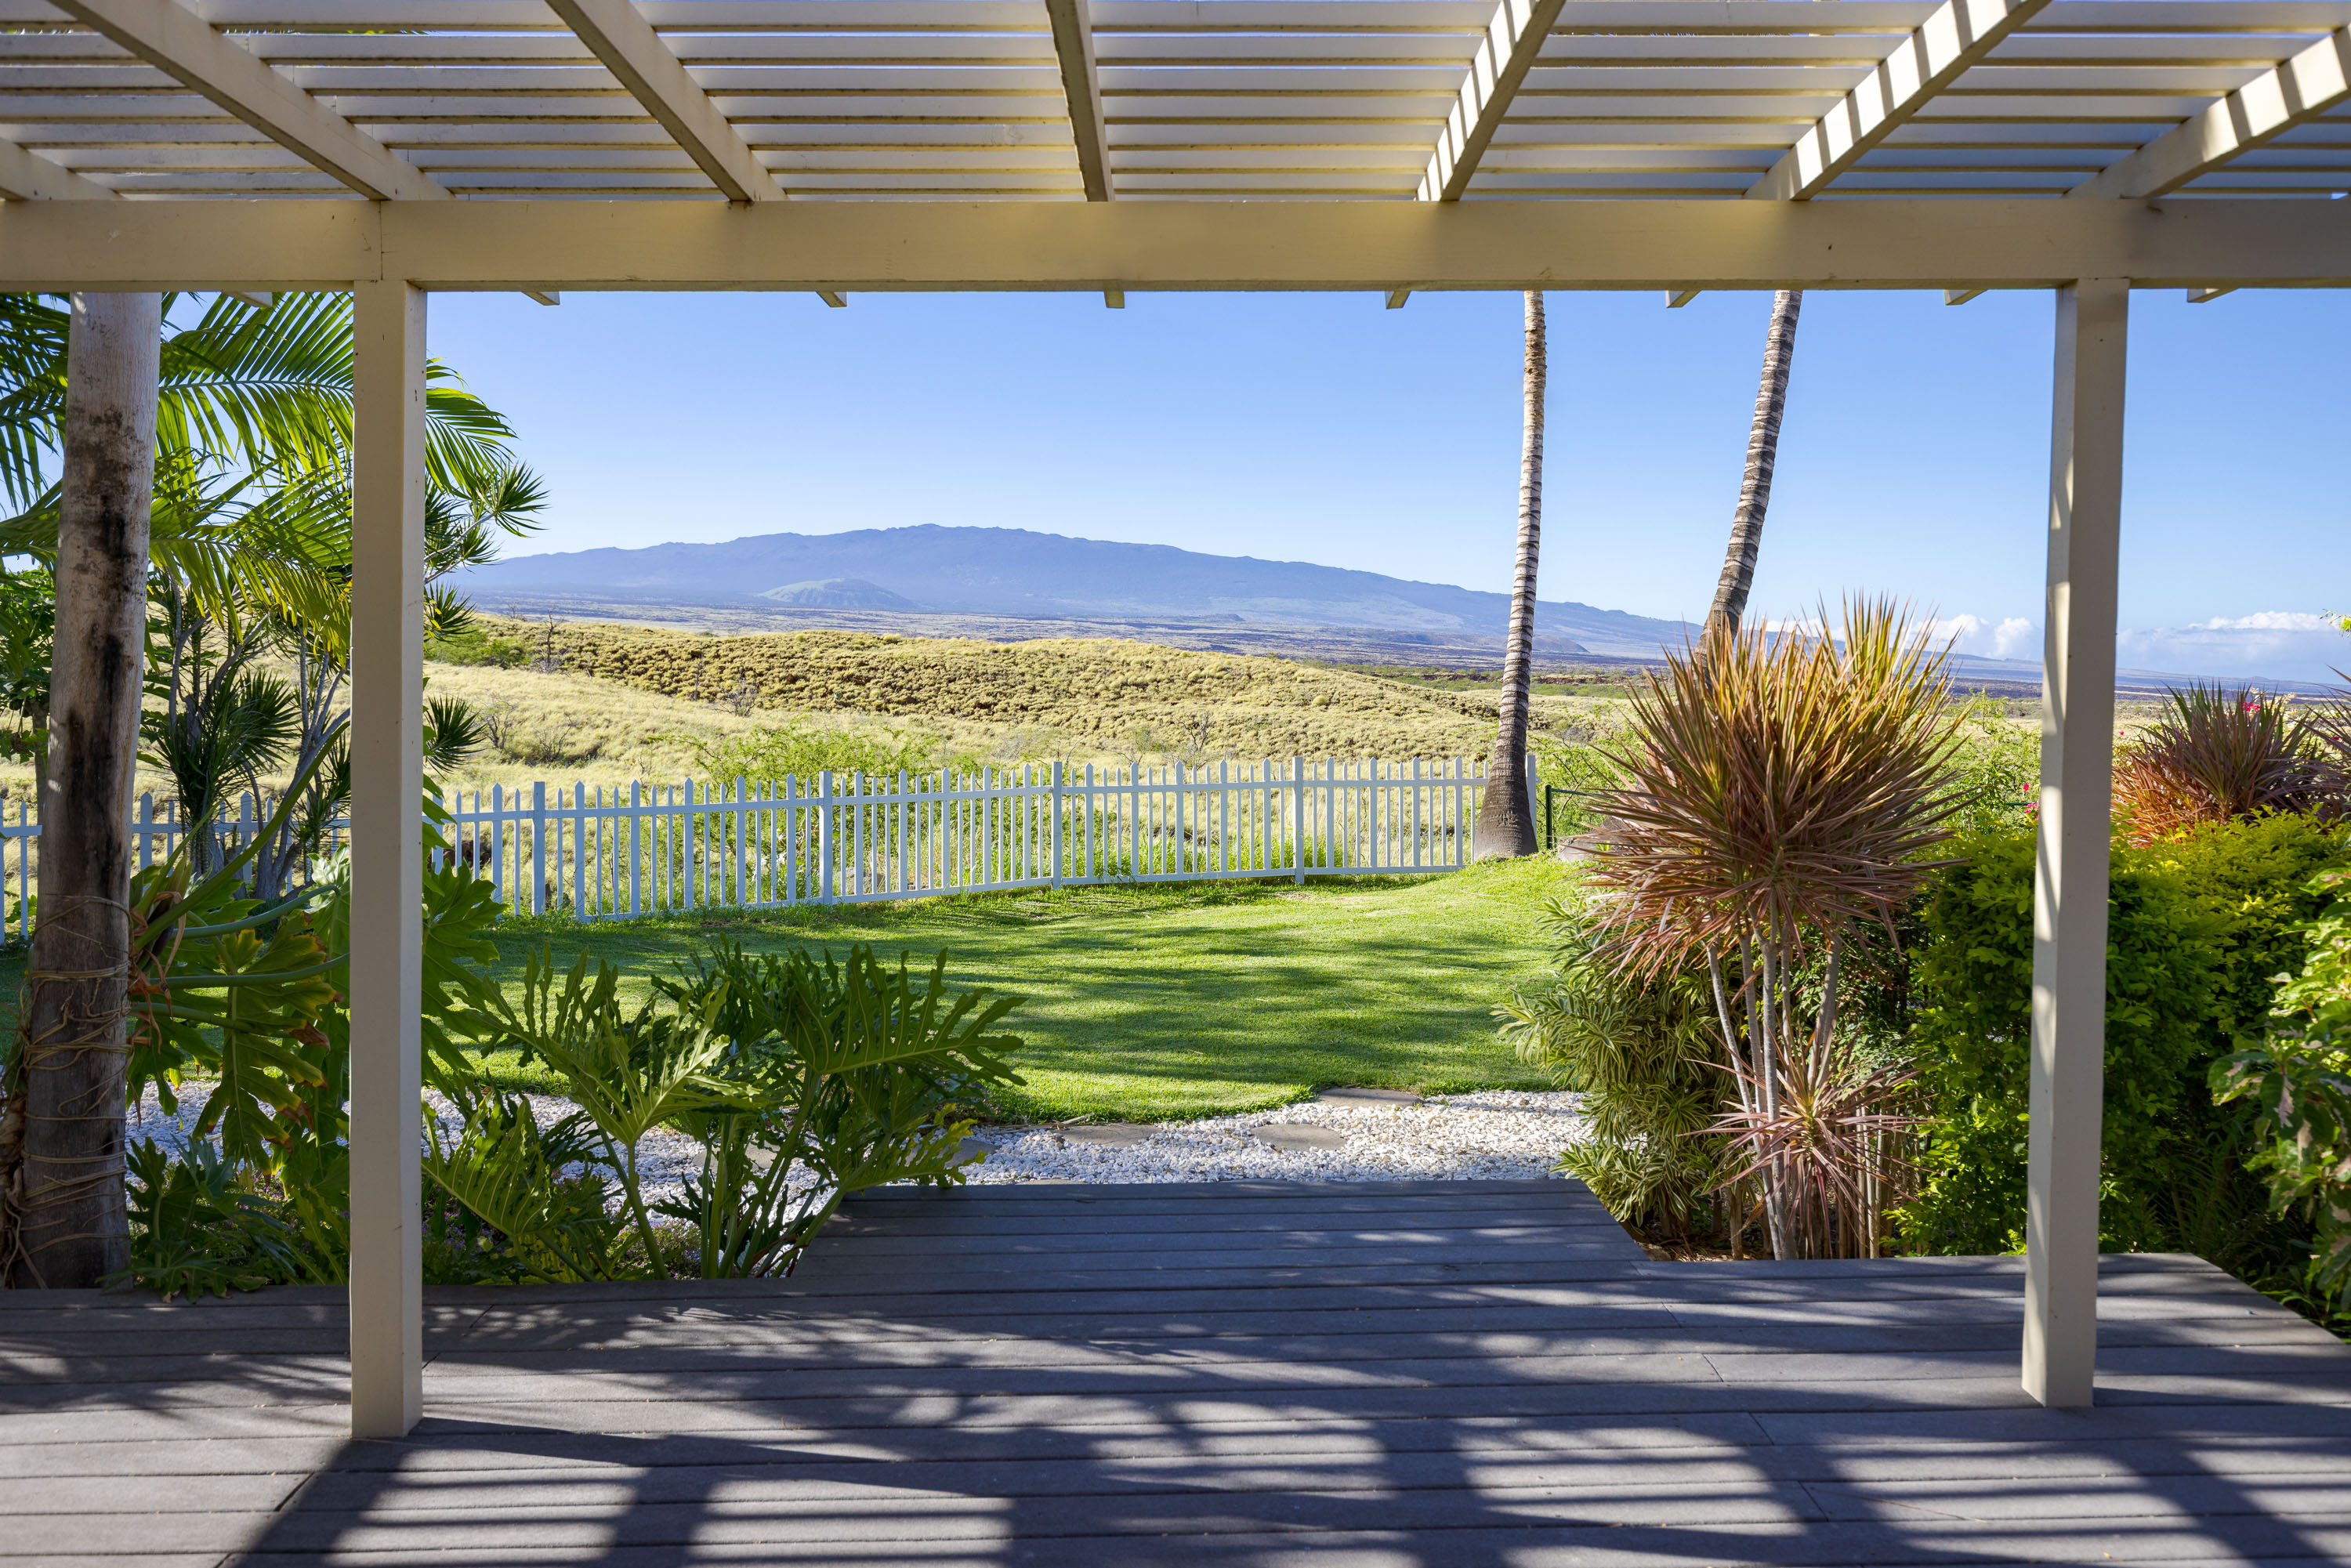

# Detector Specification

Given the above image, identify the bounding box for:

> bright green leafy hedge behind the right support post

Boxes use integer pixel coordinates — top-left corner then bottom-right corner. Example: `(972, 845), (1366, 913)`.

(1902, 816), (2351, 1267)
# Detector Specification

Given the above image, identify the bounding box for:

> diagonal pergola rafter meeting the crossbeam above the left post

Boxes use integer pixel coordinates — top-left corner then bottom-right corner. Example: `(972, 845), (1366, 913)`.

(56, 0), (449, 202)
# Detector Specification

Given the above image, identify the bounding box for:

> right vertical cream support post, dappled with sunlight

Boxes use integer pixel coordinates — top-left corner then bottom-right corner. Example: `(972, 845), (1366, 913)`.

(2024, 277), (2130, 1406)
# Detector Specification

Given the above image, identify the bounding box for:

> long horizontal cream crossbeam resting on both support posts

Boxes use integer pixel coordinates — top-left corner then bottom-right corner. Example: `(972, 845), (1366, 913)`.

(0, 197), (2351, 294)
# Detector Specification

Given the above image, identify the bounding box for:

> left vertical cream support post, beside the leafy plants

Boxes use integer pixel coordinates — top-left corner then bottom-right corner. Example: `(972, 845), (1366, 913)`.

(350, 282), (426, 1436)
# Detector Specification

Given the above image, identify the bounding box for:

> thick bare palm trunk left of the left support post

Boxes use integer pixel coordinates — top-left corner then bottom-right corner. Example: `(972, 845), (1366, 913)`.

(0, 294), (162, 1286)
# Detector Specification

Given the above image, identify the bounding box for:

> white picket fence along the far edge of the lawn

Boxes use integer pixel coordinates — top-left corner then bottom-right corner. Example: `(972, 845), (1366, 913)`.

(0, 757), (1505, 938)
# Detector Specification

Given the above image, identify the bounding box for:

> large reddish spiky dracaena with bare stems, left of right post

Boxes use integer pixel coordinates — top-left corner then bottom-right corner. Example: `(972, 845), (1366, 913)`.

(1594, 602), (1963, 1258)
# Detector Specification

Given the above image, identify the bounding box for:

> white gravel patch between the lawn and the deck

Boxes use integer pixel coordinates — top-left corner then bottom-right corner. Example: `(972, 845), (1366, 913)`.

(971, 1088), (1582, 1182)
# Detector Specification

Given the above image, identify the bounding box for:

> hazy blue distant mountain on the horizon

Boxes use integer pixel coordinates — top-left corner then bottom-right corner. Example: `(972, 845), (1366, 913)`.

(461, 524), (1690, 658)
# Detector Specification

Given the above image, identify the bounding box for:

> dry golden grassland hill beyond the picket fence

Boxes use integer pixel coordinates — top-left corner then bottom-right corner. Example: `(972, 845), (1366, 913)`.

(484, 618), (1566, 759)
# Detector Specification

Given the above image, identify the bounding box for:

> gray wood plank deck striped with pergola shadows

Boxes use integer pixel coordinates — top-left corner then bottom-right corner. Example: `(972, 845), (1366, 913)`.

(0, 1182), (2351, 1568)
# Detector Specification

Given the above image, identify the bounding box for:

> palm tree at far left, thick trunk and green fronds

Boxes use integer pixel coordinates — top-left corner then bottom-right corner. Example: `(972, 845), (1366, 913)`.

(0, 294), (538, 1286)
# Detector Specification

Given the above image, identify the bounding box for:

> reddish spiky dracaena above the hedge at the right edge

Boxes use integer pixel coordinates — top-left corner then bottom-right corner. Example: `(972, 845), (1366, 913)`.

(2114, 684), (2346, 844)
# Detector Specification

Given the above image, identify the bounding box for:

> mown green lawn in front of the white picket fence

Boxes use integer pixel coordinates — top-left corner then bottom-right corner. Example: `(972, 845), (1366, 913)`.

(0, 858), (1561, 1121)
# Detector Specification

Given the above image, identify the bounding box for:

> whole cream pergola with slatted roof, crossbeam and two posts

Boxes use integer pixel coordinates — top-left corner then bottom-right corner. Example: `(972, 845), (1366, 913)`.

(0, 0), (2351, 1436)
